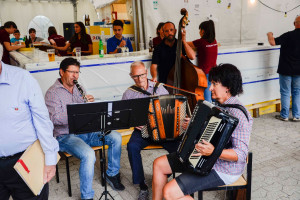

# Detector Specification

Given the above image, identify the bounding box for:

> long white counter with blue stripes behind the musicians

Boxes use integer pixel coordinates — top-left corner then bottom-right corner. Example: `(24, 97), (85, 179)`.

(10, 45), (280, 105)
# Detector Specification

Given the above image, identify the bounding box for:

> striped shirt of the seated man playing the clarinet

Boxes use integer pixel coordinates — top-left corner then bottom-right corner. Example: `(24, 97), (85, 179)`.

(45, 79), (84, 137)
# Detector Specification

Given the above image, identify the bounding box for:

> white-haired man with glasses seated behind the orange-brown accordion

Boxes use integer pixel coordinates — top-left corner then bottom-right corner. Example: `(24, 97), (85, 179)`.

(122, 61), (178, 200)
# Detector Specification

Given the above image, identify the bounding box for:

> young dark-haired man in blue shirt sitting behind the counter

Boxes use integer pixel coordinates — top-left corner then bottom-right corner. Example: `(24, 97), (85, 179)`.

(107, 20), (133, 54)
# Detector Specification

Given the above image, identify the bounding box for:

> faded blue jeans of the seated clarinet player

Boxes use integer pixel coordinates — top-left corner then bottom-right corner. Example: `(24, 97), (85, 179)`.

(56, 131), (122, 199)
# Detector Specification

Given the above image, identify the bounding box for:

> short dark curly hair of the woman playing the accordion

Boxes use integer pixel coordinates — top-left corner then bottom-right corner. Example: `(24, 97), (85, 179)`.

(209, 63), (243, 96)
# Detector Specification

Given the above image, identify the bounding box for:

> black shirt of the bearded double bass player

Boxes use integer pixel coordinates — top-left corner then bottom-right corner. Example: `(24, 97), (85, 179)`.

(152, 39), (186, 83)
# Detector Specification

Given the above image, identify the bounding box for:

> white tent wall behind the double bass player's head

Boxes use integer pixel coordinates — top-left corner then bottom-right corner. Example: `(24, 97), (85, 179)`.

(142, 0), (300, 45)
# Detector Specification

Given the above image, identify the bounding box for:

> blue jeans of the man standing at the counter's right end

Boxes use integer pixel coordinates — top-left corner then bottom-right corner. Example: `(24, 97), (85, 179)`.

(279, 74), (300, 118)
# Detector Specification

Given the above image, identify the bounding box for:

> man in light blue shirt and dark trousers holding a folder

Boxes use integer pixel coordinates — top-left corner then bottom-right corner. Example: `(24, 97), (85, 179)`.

(0, 44), (58, 200)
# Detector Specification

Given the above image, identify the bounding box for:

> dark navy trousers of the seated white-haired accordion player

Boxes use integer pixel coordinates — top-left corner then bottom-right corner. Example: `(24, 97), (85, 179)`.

(127, 129), (179, 184)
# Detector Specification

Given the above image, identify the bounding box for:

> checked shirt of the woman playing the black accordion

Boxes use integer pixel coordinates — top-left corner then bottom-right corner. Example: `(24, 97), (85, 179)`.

(213, 97), (253, 175)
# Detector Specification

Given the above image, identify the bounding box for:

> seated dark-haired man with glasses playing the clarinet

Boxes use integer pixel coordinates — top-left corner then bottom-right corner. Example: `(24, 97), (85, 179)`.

(45, 58), (125, 199)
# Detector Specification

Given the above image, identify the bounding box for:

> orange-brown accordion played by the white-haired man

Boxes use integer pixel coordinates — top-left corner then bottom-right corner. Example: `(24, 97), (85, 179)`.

(141, 95), (187, 142)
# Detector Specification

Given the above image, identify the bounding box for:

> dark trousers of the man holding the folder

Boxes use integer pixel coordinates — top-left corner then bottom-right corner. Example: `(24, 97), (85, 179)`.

(0, 152), (49, 200)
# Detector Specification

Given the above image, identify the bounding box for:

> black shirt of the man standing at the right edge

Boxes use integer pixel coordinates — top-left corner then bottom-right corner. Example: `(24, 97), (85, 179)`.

(275, 28), (300, 76)
